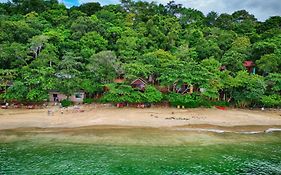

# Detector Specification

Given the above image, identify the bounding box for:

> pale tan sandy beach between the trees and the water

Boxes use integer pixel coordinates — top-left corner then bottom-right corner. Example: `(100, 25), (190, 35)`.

(0, 105), (281, 131)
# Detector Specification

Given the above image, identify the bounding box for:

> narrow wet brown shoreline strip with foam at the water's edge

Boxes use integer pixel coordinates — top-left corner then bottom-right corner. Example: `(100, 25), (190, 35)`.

(0, 125), (281, 134)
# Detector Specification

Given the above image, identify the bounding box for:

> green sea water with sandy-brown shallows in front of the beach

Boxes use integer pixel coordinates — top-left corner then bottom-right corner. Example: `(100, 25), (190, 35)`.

(0, 128), (281, 175)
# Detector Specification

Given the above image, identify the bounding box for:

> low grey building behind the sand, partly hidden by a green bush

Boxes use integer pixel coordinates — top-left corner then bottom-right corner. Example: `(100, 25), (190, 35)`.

(49, 90), (85, 103)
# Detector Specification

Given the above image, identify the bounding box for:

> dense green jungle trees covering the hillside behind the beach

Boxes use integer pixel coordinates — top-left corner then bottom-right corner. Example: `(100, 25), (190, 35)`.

(0, 0), (281, 107)
